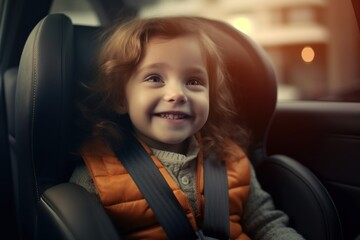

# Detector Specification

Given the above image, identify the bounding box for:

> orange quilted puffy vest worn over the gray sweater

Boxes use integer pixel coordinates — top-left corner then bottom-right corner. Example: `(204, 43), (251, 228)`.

(81, 139), (250, 240)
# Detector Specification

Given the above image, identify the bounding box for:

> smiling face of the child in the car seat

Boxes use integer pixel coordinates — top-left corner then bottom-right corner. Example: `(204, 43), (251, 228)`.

(126, 36), (209, 152)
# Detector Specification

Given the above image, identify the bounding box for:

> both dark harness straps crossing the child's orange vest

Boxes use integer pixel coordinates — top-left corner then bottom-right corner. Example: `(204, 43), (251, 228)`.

(115, 134), (230, 240)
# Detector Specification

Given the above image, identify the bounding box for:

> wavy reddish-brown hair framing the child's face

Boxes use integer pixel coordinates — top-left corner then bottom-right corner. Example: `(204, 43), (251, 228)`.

(81, 17), (248, 159)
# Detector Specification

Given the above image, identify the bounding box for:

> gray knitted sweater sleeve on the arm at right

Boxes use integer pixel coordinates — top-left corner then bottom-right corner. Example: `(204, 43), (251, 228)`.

(242, 168), (304, 240)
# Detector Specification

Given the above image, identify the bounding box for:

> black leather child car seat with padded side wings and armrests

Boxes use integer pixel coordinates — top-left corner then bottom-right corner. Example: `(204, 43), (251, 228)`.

(13, 14), (341, 240)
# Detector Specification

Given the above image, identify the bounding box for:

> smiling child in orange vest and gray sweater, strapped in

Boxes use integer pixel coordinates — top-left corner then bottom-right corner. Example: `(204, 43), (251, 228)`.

(70, 17), (302, 239)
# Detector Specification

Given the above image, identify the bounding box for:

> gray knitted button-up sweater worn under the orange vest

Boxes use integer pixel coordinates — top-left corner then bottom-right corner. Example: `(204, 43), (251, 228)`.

(70, 141), (304, 240)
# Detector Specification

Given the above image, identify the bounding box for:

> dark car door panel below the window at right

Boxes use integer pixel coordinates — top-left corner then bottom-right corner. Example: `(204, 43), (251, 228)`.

(266, 101), (360, 239)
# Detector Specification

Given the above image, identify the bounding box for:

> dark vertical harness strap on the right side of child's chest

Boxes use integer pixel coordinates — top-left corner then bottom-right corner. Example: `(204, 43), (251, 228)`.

(202, 155), (230, 239)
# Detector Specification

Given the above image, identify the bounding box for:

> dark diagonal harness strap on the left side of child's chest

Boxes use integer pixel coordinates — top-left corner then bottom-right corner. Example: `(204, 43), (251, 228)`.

(115, 136), (197, 240)
